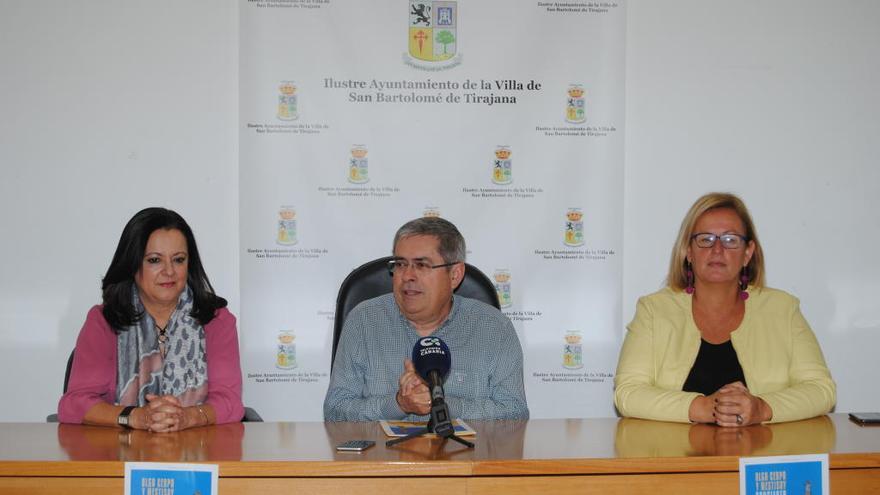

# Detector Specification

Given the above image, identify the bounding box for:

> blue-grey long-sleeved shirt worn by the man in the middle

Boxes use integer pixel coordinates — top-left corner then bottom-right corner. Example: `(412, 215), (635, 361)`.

(324, 294), (529, 421)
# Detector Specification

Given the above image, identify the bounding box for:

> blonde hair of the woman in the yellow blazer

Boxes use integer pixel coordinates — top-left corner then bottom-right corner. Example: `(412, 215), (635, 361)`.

(666, 192), (765, 290)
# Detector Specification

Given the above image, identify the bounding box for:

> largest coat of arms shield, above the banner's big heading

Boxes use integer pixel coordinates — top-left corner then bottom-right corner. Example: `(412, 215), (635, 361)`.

(408, 0), (458, 62)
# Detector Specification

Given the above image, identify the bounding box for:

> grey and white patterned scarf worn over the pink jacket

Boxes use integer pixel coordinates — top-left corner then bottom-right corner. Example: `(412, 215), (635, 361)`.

(116, 285), (208, 407)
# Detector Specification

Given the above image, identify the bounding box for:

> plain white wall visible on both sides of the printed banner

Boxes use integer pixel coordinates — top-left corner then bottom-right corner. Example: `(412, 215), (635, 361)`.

(0, 0), (880, 421)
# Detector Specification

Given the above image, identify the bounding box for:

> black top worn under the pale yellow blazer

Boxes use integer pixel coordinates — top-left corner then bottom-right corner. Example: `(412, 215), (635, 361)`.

(681, 340), (748, 395)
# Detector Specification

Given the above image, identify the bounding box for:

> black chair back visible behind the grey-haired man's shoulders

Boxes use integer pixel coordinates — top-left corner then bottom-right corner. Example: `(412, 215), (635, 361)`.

(330, 256), (501, 366)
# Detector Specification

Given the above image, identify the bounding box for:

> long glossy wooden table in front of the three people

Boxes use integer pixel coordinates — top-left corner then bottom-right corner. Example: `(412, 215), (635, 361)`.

(0, 414), (880, 495)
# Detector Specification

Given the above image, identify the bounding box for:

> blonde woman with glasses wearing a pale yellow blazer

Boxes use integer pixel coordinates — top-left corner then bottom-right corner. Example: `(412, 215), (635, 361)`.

(614, 193), (836, 426)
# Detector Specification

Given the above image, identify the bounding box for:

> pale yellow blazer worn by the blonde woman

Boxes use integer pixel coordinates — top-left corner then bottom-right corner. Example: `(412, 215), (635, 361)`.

(614, 287), (837, 423)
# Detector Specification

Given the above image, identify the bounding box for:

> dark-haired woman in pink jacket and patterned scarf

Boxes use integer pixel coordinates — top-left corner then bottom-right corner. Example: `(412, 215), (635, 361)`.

(58, 208), (244, 432)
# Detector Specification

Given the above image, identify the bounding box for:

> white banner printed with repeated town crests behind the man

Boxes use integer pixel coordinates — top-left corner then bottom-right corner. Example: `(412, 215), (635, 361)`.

(239, 0), (626, 421)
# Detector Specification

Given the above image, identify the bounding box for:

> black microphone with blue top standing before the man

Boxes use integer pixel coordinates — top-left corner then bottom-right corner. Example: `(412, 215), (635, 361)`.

(412, 336), (455, 438)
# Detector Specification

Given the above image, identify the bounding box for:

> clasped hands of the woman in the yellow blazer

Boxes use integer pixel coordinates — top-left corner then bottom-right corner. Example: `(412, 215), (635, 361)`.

(690, 382), (773, 427)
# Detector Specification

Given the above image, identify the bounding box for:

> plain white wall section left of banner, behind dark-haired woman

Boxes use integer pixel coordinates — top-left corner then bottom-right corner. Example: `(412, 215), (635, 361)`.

(0, 0), (239, 421)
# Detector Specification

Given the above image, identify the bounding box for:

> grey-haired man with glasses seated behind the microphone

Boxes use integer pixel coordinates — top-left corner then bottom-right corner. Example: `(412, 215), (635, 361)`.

(324, 217), (529, 421)
